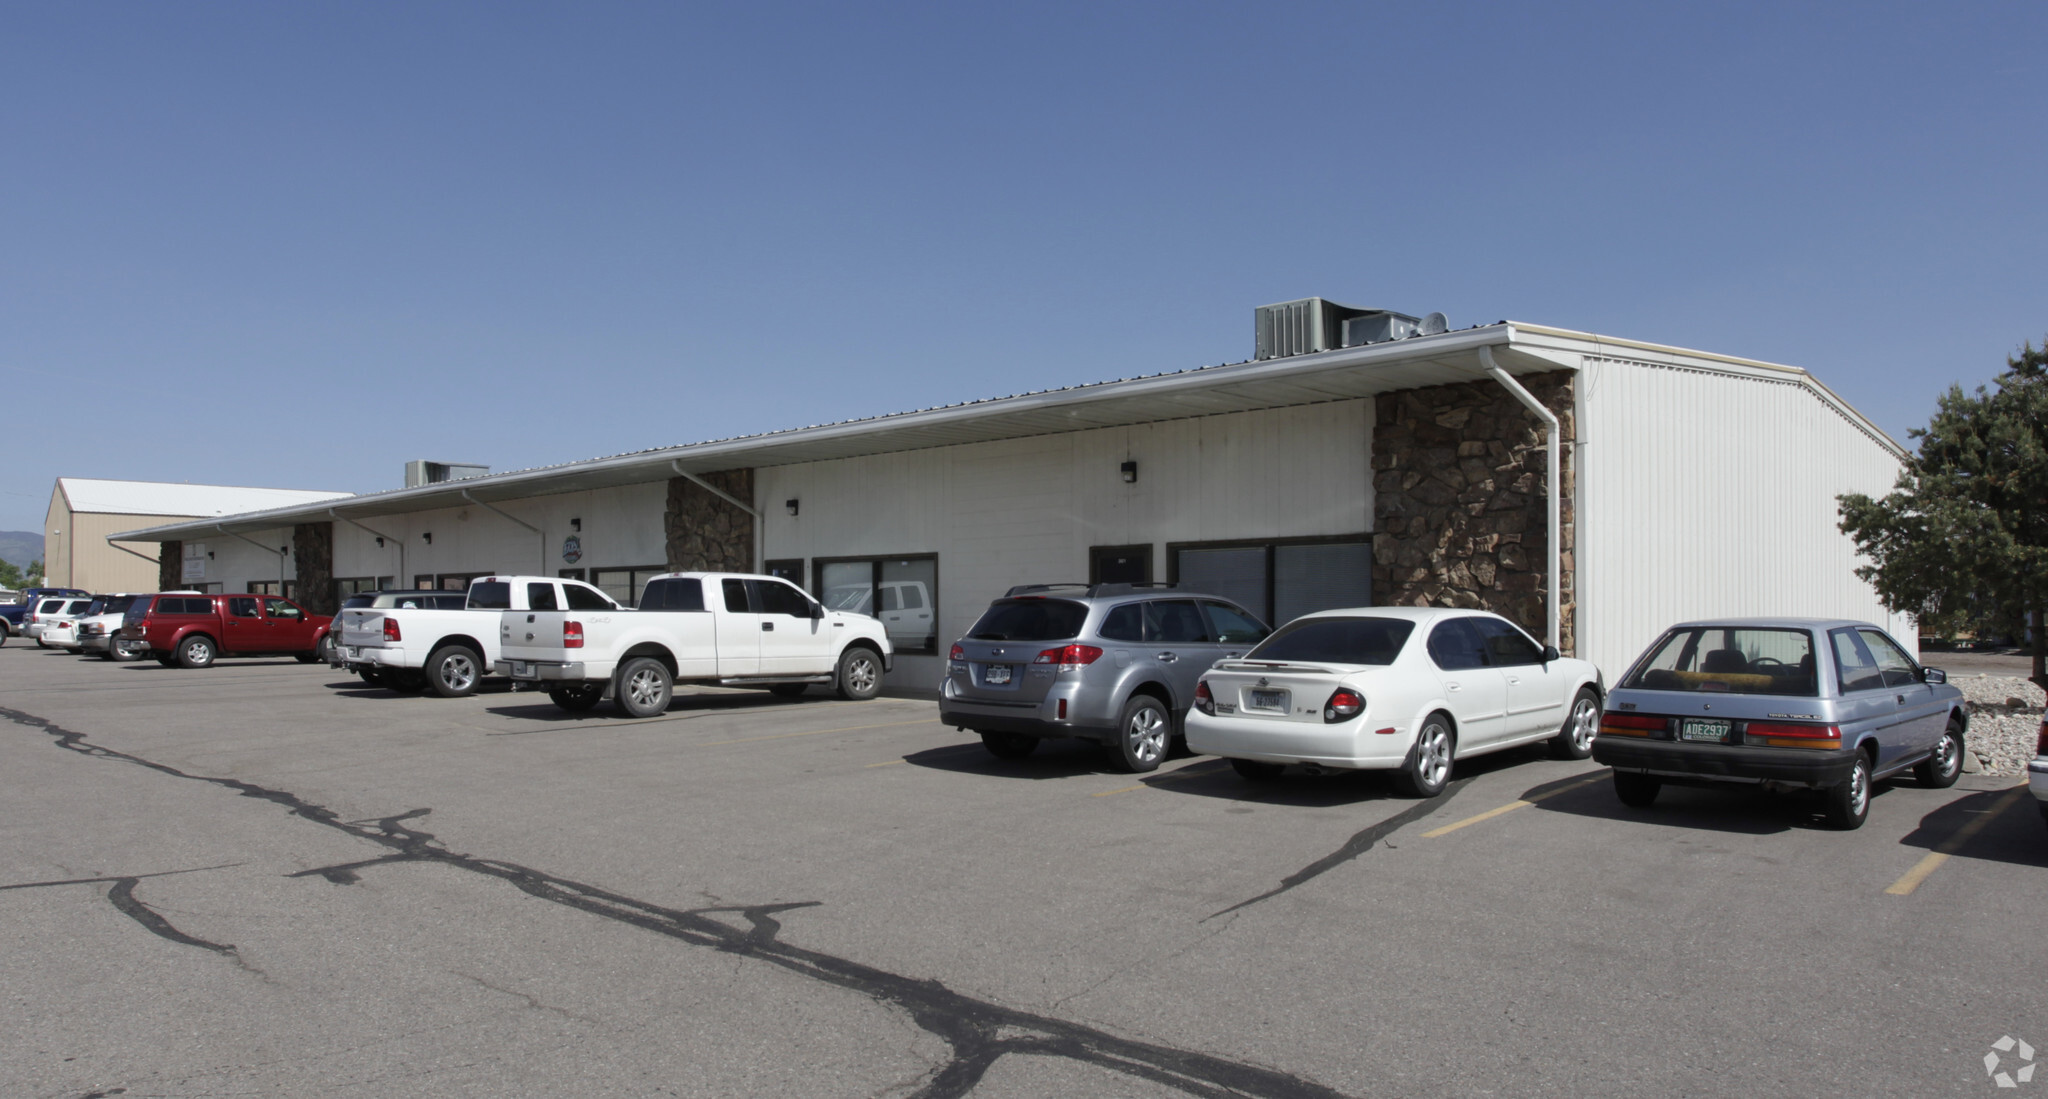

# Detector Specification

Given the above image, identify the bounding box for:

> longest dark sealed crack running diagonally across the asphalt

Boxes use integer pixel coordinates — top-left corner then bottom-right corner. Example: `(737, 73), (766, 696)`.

(0, 708), (1351, 1099)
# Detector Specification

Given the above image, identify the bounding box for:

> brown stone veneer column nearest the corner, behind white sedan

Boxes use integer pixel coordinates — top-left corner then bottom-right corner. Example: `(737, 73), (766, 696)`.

(1372, 370), (1577, 655)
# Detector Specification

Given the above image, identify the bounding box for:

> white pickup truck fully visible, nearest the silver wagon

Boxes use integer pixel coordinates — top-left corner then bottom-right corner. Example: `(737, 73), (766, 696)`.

(494, 573), (895, 718)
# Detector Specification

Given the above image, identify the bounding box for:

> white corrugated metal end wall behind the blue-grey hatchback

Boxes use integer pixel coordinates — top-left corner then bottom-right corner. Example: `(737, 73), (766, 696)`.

(1577, 356), (1915, 682)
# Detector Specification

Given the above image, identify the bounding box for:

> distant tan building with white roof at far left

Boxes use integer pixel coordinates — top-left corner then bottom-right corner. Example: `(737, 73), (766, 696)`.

(43, 477), (350, 594)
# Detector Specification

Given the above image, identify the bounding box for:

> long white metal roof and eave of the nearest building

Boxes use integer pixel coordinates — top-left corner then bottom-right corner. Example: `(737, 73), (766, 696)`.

(115, 321), (1903, 540)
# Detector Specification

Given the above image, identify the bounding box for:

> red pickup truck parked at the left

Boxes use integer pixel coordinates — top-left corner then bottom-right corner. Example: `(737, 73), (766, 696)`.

(117, 591), (334, 667)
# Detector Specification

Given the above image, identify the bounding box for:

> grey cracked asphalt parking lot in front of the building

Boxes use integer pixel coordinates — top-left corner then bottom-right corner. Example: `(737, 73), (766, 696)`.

(0, 641), (2048, 1099)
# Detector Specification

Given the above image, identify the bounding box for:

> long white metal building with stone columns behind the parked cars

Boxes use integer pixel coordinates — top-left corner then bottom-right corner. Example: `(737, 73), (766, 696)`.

(117, 311), (1913, 688)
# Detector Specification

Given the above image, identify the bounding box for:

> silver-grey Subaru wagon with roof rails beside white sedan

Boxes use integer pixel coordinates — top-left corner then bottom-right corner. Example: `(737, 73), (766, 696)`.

(938, 583), (1272, 772)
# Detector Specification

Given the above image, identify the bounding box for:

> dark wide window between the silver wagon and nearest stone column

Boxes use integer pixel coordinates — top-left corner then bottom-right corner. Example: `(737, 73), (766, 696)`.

(1165, 534), (1372, 626)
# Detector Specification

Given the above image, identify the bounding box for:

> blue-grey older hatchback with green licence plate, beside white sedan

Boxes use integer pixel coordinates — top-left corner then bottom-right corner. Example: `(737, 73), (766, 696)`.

(1593, 618), (1968, 829)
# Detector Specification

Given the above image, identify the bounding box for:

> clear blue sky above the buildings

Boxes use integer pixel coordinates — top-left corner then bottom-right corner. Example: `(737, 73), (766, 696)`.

(0, 2), (2048, 530)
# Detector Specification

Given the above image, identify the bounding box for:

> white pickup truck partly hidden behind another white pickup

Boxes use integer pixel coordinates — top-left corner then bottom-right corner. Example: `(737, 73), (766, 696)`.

(332, 577), (618, 698)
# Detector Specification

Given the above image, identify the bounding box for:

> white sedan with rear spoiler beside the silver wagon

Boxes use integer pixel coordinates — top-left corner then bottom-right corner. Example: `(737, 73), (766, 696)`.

(1188, 606), (1604, 798)
